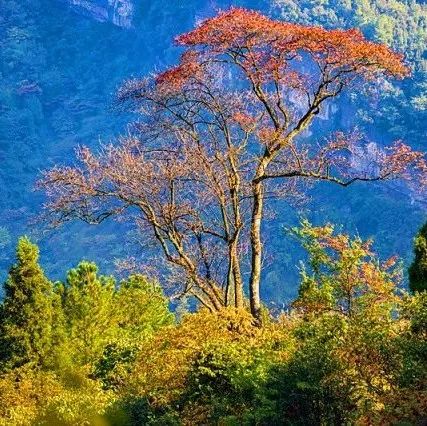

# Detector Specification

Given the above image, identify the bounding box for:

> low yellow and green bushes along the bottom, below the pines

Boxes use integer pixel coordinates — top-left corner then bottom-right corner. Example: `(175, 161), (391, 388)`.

(0, 296), (427, 426)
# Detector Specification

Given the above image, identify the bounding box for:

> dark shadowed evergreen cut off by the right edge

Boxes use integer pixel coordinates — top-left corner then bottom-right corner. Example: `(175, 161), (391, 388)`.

(409, 222), (427, 292)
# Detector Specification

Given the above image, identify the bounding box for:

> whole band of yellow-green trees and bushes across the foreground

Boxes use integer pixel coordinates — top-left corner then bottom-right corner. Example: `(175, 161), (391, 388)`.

(0, 222), (427, 425)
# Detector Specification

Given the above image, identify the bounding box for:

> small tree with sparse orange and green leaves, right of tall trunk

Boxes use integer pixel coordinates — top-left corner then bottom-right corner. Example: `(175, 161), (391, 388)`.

(293, 221), (402, 316)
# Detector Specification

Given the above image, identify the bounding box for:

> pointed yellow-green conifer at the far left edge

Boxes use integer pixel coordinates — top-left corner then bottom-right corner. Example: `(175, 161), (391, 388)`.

(0, 237), (63, 369)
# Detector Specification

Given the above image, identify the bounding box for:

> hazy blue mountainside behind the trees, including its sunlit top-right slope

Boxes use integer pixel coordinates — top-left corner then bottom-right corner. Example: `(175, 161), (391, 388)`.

(0, 0), (427, 302)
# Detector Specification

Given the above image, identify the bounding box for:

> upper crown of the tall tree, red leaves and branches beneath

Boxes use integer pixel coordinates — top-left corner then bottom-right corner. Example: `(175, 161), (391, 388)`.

(119, 8), (407, 141)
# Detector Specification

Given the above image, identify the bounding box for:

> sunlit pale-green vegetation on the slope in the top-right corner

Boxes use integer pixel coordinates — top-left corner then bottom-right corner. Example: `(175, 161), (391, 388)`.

(272, 0), (427, 138)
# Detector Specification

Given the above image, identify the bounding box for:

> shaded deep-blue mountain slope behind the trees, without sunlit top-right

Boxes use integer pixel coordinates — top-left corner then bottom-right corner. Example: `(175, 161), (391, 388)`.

(0, 0), (426, 301)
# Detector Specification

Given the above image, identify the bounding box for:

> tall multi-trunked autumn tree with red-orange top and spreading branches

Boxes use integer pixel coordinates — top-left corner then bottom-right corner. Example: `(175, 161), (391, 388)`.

(39, 8), (426, 318)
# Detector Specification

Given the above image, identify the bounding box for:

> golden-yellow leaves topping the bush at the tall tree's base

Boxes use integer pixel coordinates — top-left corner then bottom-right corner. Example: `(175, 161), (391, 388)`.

(130, 308), (288, 404)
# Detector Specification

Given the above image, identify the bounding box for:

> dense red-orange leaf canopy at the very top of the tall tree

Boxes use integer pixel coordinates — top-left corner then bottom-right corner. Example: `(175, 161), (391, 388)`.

(176, 8), (408, 83)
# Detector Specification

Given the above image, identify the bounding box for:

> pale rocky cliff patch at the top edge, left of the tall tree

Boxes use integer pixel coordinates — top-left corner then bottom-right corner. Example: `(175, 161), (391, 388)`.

(67, 0), (135, 28)
